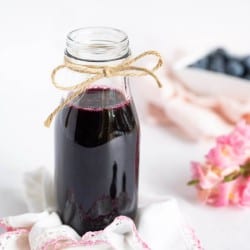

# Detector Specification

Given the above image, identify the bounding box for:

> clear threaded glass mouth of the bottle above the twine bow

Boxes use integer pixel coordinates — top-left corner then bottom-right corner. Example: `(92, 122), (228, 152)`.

(65, 27), (130, 62)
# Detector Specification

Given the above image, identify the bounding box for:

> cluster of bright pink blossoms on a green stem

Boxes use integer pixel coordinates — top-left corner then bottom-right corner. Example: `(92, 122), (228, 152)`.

(190, 121), (250, 206)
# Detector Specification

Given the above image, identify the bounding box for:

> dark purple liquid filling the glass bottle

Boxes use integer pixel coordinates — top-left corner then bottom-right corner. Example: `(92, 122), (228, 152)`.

(55, 88), (139, 234)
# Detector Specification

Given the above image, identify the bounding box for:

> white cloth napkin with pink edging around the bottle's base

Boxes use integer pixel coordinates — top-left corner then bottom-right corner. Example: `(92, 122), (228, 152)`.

(0, 168), (203, 250)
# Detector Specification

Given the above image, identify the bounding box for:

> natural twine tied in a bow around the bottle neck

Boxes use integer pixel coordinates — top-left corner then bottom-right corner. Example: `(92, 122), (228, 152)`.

(44, 51), (163, 127)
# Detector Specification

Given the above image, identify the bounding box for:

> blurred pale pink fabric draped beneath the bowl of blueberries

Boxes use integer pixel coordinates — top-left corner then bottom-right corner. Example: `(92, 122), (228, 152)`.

(133, 52), (250, 141)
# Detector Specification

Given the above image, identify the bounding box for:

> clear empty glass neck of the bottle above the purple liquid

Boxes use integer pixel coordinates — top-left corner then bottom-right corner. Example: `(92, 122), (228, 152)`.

(65, 27), (131, 100)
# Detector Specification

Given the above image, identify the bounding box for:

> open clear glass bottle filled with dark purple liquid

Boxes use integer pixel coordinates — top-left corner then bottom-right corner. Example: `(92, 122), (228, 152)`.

(55, 27), (140, 235)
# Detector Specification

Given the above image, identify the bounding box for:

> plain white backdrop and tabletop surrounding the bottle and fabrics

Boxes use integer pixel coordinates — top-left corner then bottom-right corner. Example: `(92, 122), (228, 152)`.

(0, 0), (250, 250)
